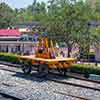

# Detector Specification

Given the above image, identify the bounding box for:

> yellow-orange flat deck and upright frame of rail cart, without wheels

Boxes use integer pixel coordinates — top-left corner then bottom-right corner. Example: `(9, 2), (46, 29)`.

(19, 37), (75, 69)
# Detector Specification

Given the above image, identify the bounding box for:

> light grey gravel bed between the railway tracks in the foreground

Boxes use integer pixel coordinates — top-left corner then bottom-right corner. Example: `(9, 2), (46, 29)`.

(0, 65), (100, 100)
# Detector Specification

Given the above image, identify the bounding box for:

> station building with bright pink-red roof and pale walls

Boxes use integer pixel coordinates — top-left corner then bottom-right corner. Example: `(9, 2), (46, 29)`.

(0, 29), (33, 54)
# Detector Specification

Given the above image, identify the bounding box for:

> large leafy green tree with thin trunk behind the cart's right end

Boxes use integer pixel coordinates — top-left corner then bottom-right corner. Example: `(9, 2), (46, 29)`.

(45, 0), (93, 56)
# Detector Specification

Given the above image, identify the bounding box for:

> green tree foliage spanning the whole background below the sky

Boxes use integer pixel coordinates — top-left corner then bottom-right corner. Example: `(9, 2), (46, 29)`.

(0, 0), (100, 56)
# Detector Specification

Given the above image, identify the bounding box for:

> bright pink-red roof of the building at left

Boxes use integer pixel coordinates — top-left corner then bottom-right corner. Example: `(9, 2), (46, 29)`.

(0, 29), (21, 37)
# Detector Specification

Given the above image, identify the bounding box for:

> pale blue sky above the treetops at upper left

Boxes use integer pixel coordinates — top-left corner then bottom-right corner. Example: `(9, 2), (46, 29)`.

(0, 0), (48, 8)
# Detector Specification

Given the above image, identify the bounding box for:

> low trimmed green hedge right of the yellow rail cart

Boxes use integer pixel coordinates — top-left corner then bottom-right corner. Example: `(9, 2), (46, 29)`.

(71, 64), (100, 75)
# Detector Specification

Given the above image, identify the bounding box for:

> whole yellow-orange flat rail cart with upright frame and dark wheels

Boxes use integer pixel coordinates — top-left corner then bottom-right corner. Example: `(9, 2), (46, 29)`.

(19, 37), (75, 75)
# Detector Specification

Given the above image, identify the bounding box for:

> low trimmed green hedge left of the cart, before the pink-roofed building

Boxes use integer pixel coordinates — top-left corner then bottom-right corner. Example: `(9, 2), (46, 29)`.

(0, 53), (19, 64)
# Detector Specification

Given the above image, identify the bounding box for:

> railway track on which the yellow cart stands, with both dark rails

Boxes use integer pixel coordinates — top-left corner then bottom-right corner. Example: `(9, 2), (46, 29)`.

(1, 63), (100, 91)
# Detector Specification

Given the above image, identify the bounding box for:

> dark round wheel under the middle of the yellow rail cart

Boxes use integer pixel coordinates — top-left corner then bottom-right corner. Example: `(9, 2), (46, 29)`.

(38, 64), (48, 76)
